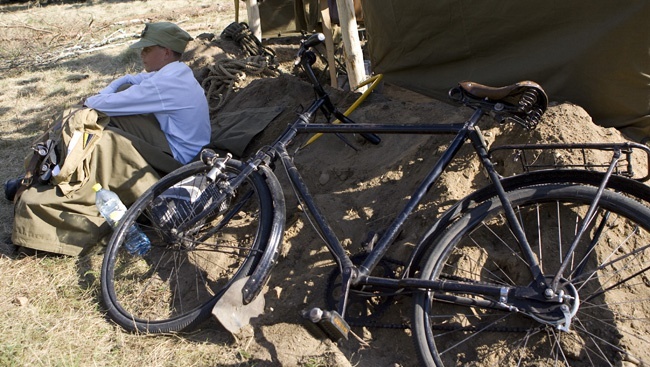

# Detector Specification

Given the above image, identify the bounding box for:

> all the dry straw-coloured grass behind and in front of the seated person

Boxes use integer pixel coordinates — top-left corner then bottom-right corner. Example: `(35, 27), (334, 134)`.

(0, 0), (272, 367)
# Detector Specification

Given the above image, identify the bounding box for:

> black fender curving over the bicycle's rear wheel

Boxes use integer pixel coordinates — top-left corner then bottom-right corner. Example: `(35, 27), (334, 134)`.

(404, 169), (650, 276)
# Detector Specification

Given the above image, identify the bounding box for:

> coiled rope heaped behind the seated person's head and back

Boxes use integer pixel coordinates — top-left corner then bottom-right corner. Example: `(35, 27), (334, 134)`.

(201, 23), (280, 115)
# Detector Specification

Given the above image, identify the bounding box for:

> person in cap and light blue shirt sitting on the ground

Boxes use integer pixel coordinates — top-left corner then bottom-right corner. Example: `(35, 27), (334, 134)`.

(5, 22), (211, 256)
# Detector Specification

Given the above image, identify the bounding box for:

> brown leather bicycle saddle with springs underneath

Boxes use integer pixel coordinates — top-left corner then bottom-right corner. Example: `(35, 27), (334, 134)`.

(449, 80), (548, 129)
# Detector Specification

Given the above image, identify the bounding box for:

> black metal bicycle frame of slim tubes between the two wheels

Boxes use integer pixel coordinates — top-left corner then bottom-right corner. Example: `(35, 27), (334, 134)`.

(251, 94), (545, 312)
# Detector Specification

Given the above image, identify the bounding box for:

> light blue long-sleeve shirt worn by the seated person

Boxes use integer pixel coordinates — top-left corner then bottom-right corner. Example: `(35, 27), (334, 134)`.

(85, 61), (211, 163)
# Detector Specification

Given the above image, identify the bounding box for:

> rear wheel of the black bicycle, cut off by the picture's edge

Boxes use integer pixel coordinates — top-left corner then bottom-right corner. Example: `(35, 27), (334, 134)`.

(413, 184), (650, 366)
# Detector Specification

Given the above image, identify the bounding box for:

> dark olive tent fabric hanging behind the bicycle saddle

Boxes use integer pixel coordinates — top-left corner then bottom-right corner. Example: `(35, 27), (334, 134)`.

(362, 0), (650, 141)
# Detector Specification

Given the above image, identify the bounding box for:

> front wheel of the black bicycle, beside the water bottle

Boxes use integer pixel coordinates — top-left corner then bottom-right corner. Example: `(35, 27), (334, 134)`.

(101, 159), (274, 333)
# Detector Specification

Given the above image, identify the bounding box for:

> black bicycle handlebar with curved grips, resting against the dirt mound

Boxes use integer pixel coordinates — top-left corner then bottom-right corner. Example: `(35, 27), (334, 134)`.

(294, 33), (381, 145)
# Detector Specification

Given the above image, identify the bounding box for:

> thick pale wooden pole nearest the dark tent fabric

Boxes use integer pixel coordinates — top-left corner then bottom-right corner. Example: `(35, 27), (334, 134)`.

(336, 0), (367, 92)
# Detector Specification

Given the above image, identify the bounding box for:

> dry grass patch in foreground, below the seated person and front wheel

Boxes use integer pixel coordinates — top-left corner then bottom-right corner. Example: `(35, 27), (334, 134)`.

(0, 256), (240, 366)
